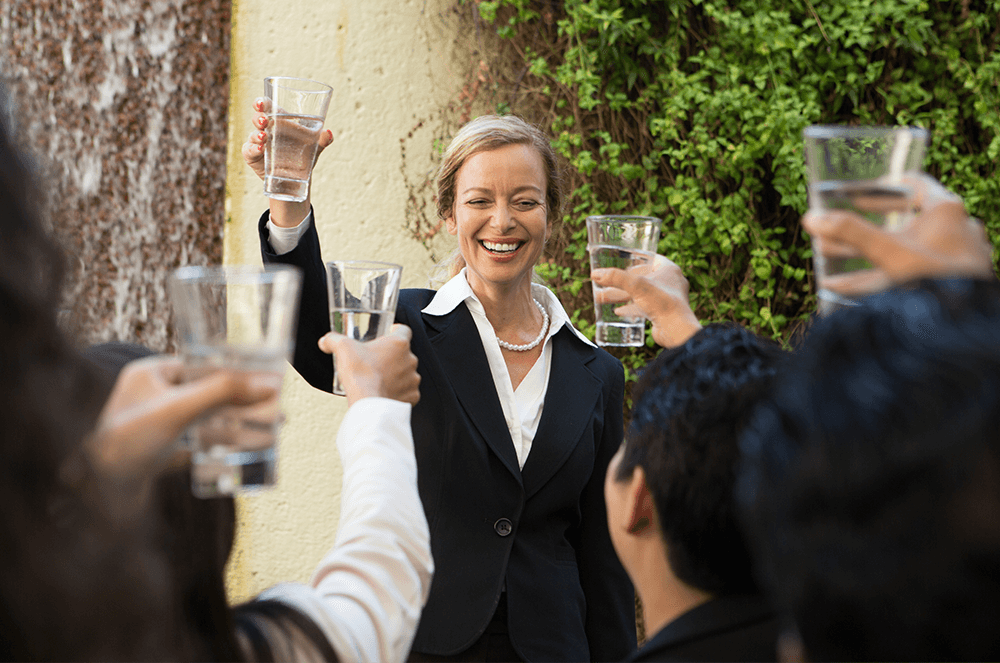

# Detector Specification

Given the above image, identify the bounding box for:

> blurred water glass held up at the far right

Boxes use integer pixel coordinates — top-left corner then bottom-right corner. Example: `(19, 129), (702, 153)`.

(803, 126), (929, 315)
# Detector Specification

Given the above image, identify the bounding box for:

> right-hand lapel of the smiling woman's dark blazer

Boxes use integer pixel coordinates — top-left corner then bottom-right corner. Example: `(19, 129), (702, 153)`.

(521, 328), (603, 497)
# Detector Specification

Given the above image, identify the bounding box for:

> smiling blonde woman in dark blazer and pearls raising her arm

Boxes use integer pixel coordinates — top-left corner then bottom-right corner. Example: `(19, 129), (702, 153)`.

(243, 111), (635, 661)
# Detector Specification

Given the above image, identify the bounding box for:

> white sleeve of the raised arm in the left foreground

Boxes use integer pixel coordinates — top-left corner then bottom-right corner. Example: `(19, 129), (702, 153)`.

(261, 398), (434, 662)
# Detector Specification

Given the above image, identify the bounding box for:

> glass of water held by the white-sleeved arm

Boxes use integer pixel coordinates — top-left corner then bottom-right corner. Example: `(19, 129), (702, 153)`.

(326, 260), (403, 396)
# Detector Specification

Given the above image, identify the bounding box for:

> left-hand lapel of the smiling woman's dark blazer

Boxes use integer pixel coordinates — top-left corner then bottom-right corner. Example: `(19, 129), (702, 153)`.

(422, 304), (521, 482)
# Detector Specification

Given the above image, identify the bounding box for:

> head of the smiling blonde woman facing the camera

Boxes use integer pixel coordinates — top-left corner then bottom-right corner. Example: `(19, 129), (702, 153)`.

(437, 115), (564, 279)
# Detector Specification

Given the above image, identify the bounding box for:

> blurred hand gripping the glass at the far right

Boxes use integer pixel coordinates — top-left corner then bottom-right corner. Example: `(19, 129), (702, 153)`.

(802, 175), (996, 295)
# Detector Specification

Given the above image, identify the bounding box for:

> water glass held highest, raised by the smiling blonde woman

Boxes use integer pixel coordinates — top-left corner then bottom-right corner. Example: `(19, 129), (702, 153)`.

(264, 76), (333, 202)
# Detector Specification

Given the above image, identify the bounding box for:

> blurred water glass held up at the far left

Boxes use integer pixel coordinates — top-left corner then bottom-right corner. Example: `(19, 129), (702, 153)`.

(170, 265), (302, 498)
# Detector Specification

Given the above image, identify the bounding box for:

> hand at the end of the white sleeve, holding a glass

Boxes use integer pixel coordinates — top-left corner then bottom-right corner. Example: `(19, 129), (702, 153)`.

(319, 324), (420, 405)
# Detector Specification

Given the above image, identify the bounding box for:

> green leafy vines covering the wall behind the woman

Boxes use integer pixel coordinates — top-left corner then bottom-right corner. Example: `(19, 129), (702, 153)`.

(477, 0), (1000, 369)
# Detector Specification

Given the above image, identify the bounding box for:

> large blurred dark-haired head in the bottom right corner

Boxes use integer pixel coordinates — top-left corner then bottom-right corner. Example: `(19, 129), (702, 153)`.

(738, 281), (1000, 660)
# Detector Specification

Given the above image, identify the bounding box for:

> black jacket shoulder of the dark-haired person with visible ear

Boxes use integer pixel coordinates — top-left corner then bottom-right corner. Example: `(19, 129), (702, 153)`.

(628, 596), (779, 661)
